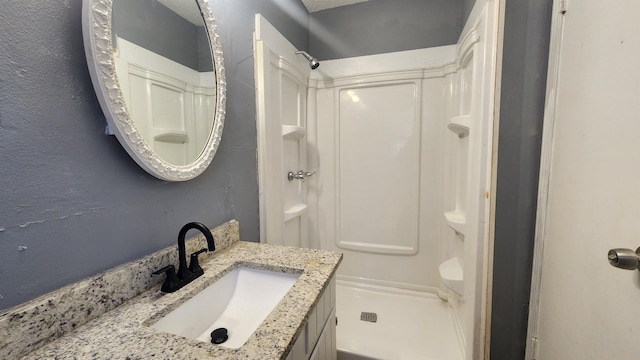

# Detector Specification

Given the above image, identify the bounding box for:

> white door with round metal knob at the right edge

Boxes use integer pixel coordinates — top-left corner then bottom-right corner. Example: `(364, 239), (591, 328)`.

(530, 0), (640, 360)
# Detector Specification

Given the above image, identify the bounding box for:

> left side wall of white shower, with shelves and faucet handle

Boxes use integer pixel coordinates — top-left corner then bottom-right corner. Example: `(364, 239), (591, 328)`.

(254, 15), (312, 247)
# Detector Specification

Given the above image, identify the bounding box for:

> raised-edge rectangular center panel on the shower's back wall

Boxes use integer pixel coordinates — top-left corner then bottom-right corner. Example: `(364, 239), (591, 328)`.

(336, 80), (421, 254)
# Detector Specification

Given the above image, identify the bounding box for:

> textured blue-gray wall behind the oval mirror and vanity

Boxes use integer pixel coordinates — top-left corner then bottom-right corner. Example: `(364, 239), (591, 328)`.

(0, 0), (308, 309)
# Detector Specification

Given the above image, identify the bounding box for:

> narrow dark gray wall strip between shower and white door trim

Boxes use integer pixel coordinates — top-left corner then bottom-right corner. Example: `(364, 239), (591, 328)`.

(491, 0), (553, 360)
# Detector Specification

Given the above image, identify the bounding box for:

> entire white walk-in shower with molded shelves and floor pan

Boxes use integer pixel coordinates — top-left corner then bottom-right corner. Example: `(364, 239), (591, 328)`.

(256, 2), (497, 360)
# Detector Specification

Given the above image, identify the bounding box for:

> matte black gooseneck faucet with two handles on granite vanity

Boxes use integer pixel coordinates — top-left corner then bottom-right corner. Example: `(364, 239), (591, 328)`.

(154, 222), (216, 292)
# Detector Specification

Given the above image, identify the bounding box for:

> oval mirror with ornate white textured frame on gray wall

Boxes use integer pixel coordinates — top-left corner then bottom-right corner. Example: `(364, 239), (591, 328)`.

(82, 0), (226, 181)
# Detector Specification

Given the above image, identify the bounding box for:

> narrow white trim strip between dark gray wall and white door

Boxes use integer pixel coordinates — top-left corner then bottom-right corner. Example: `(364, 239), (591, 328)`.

(525, 0), (564, 360)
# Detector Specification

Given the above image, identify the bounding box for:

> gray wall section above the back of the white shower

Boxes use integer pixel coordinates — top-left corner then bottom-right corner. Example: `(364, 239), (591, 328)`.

(309, 0), (460, 60)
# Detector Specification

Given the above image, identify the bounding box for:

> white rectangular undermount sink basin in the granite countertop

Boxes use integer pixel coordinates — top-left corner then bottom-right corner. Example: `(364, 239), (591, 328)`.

(151, 267), (300, 349)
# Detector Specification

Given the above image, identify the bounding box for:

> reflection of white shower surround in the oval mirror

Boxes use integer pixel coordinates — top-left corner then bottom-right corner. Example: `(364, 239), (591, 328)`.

(113, 37), (216, 165)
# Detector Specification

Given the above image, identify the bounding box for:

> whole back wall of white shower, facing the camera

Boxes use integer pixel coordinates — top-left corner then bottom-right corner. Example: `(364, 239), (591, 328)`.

(309, 46), (455, 291)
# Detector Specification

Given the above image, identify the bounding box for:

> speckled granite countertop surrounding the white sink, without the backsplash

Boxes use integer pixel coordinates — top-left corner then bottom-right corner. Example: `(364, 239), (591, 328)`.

(17, 241), (342, 360)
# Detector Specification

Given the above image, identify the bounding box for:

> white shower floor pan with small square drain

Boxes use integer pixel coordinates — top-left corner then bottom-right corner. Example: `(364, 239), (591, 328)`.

(336, 280), (462, 360)
